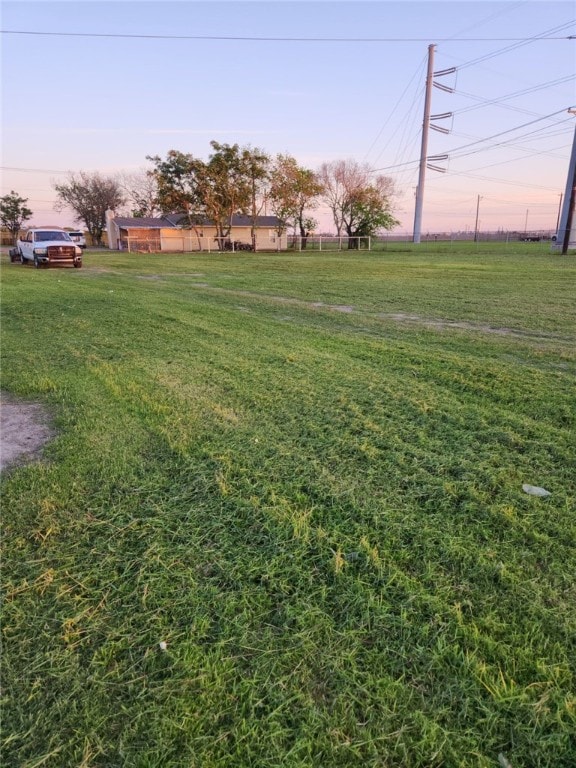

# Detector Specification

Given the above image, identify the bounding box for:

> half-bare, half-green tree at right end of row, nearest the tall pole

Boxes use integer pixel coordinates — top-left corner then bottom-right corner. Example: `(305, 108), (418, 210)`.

(318, 160), (399, 248)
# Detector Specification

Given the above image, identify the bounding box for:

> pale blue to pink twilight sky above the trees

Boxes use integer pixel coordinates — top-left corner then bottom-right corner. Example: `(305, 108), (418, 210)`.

(0, 0), (576, 235)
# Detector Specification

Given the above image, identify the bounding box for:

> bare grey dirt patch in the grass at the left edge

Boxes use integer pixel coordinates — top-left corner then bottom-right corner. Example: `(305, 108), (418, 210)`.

(0, 393), (54, 472)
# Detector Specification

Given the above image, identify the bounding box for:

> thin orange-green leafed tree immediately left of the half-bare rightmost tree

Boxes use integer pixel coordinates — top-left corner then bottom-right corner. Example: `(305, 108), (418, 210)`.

(270, 155), (323, 248)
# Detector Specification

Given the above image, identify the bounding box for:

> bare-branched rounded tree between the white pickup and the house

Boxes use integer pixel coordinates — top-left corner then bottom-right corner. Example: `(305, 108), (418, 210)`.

(54, 171), (126, 245)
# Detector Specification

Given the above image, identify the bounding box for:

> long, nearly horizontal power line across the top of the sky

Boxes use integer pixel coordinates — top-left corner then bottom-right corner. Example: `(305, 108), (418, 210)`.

(0, 29), (576, 42)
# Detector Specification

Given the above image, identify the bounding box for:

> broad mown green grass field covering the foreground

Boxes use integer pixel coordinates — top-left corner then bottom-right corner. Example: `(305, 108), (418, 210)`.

(2, 244), (576, 768)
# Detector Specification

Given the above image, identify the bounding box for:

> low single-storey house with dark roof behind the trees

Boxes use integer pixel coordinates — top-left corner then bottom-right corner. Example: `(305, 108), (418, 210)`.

(106, 211), (288, 253)
